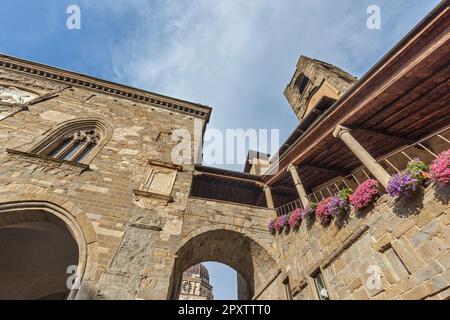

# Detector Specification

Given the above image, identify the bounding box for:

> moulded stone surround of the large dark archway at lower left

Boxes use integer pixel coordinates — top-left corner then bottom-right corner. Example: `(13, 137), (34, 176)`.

(0, 194), (98, 299)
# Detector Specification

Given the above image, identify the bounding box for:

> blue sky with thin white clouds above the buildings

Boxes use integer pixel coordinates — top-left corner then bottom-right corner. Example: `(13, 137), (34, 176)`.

(0, 0), (439, 298)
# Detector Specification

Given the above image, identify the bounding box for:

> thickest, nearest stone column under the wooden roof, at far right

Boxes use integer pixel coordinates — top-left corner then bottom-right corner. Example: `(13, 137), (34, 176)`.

(333, 125), (390, 188)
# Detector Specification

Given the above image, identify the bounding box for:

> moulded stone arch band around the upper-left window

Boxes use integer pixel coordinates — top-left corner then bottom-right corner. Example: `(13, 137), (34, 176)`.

(28, 117), (113, 164)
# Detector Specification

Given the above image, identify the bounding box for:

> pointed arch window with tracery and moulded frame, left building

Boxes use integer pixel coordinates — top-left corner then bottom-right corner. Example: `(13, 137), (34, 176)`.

(29, 119), (111, 164)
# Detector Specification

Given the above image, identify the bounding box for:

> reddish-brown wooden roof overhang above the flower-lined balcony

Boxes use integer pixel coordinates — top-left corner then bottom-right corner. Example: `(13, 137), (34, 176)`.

(262, 1), (450, 190)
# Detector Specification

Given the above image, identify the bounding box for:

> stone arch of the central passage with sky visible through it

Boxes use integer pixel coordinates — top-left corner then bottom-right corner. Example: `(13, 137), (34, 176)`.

(168, 225), (279, 300)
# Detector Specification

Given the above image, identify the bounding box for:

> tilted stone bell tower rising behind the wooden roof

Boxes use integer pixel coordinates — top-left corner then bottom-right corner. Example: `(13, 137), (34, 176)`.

(284, 56), (357, 121)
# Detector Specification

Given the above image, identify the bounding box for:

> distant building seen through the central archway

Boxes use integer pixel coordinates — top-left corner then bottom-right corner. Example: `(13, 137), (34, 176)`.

(180, 263), (214, 300)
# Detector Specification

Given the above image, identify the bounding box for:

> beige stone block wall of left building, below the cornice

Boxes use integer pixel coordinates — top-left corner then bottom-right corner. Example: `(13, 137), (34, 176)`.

(0, 68), (203, 299)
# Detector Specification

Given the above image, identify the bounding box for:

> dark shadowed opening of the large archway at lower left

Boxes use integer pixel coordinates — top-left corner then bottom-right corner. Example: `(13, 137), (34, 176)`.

(0, 209), (79, 300)
